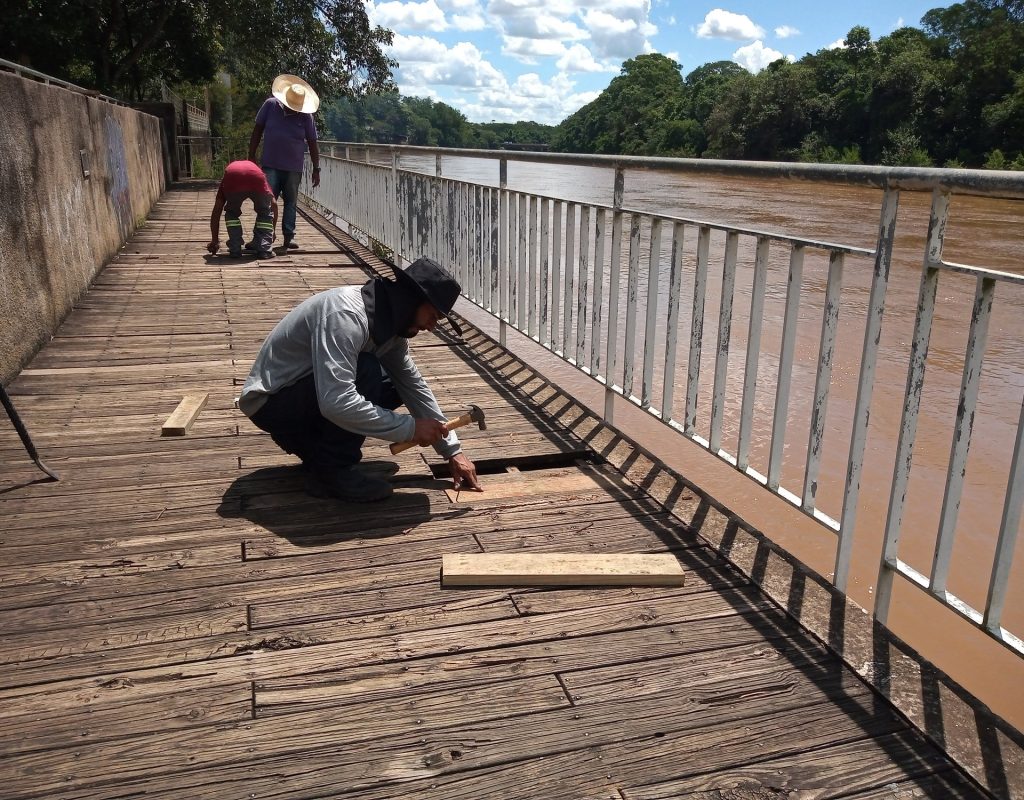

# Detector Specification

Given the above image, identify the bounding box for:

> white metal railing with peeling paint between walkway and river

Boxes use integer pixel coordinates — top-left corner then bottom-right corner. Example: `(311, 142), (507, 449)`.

(303, 142), (1024, 655)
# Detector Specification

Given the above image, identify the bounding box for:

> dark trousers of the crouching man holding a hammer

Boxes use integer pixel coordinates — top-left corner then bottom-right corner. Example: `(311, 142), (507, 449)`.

(252, 352), (401, 471)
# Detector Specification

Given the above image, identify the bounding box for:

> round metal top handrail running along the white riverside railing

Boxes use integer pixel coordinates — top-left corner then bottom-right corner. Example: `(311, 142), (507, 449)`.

(321, 139), (1024, 200)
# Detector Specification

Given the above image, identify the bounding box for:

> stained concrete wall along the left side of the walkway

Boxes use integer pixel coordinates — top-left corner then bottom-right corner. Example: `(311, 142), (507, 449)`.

(0, 73), (164, 385)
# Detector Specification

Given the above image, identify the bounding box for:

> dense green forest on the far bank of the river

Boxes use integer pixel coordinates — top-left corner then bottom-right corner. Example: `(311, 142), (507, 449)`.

(324, 0), (1024, 169)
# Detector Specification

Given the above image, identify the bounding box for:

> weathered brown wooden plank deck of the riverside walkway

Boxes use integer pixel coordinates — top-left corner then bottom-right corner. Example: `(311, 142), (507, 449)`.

(0, 184), (988, 800)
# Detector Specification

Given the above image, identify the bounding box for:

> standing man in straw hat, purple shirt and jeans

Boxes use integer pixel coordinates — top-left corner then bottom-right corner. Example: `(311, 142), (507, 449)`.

(246, 74), (319, 250)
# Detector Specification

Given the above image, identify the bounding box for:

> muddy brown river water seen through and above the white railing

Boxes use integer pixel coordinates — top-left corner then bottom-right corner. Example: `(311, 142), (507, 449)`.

(393, 159), (1024, 729)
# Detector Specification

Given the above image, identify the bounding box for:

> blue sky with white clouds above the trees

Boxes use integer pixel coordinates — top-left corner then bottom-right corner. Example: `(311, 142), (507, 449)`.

(367, 0), (950, 125)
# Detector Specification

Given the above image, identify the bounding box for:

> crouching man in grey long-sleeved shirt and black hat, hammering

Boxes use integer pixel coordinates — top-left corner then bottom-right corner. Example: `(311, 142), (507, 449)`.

(239, 258), (480, 502)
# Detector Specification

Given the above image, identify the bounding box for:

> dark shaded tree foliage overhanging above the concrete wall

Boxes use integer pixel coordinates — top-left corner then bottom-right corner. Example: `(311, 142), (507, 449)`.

(0, 0), (396, 99)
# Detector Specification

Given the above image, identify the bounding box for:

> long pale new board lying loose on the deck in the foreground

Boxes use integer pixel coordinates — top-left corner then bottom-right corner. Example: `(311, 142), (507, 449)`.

(441, 553), (685, 586)
